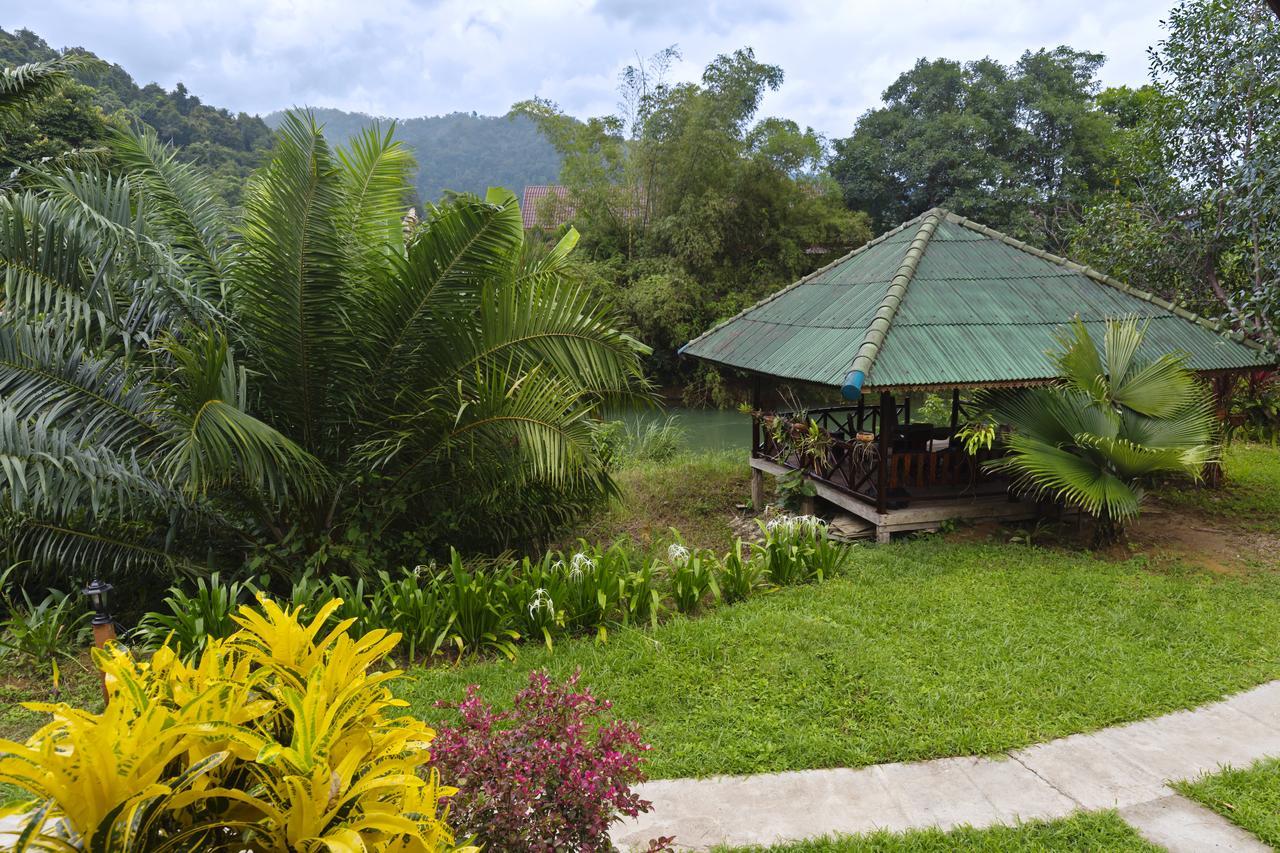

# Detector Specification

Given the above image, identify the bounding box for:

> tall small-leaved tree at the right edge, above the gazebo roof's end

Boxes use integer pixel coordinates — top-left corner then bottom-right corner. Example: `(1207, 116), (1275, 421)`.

(1073, 0), (1280, 346)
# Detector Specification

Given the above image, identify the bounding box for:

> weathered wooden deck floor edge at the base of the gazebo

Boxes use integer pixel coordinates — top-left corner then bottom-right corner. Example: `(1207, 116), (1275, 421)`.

(751, 459), (1036, 542)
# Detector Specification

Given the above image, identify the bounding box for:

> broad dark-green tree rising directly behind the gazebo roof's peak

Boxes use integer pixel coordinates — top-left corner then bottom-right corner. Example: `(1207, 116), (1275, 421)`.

(831, 46), (1115, 248)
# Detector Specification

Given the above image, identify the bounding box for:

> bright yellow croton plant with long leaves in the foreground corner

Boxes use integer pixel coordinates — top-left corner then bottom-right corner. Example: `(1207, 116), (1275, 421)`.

(0, 597), (475, 853)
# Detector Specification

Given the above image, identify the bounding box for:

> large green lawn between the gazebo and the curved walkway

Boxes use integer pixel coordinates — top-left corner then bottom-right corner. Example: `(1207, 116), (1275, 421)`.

(401, 537), (1280, 777)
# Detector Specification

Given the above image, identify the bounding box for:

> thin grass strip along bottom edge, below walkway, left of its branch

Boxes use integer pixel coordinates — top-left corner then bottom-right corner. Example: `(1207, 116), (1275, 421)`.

(717, 812), (1161, 853)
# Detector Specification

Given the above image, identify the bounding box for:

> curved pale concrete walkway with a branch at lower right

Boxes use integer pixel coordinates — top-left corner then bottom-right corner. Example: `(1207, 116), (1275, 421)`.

(613, 681), (1280, 853)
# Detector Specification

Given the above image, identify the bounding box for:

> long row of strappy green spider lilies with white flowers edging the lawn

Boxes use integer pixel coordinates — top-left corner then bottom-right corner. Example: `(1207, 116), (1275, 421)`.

(133, 516), (847, 661)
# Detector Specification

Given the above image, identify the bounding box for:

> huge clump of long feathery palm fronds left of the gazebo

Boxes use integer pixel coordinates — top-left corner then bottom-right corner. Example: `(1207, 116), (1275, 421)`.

(0, 113), (649, 584)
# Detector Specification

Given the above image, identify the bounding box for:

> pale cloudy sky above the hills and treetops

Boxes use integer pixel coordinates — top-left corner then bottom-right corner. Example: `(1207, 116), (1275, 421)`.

(0, 0), (1170, 136)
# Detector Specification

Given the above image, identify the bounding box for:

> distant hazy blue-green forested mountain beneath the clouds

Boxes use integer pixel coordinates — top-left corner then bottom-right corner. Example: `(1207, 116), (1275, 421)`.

(265, 108), (561, 201)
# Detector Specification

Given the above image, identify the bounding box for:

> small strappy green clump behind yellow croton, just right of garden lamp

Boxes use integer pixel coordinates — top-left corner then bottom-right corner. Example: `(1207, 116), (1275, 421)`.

(129, 571), (250, 661)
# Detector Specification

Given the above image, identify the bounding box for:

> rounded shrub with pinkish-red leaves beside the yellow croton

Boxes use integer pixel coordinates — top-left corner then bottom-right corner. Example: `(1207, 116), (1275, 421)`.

(431, 671), (669, 853)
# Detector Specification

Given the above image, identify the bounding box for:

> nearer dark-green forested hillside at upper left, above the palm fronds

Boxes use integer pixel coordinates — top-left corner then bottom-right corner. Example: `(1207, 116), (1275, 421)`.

(0, 29), (271, 204)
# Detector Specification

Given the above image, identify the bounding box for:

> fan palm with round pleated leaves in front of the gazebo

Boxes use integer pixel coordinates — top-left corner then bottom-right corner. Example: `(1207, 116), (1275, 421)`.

(980, 319), (1215, 544)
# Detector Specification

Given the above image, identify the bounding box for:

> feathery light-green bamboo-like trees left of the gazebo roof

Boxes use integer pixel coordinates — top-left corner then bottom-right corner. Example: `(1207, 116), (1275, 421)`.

(515, 49), (870, 391)
